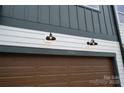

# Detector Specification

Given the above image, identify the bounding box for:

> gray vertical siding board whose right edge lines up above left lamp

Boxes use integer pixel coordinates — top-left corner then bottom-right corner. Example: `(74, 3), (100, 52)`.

(38, 5), (49, 24)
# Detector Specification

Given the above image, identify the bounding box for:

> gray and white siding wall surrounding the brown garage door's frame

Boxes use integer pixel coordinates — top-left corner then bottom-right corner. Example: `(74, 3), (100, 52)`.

(0, 6), (124, 86)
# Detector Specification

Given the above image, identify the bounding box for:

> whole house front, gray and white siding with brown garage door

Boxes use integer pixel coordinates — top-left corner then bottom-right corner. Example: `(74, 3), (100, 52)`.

(0, 5), (124, 86)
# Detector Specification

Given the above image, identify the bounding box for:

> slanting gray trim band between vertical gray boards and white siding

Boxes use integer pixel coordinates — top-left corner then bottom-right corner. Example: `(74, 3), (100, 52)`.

(0, 17), (117, 41)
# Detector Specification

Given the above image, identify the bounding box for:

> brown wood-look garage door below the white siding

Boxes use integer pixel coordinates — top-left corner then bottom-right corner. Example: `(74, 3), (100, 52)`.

(0, 54), (115, 86)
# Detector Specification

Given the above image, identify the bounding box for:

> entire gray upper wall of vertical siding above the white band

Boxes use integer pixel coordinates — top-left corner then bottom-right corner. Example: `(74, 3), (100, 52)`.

(0, 5), (116, 40)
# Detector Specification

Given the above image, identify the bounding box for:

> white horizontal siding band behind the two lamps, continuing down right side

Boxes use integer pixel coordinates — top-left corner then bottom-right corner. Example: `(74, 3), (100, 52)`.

(0, 25), (124, 86)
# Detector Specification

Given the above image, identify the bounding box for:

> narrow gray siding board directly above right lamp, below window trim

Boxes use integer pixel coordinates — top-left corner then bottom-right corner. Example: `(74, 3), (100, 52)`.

(85, 9), (93, 32)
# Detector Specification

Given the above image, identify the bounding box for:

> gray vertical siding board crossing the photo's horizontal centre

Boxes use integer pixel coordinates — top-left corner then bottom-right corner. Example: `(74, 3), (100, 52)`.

(60, 5), (69, 27)
